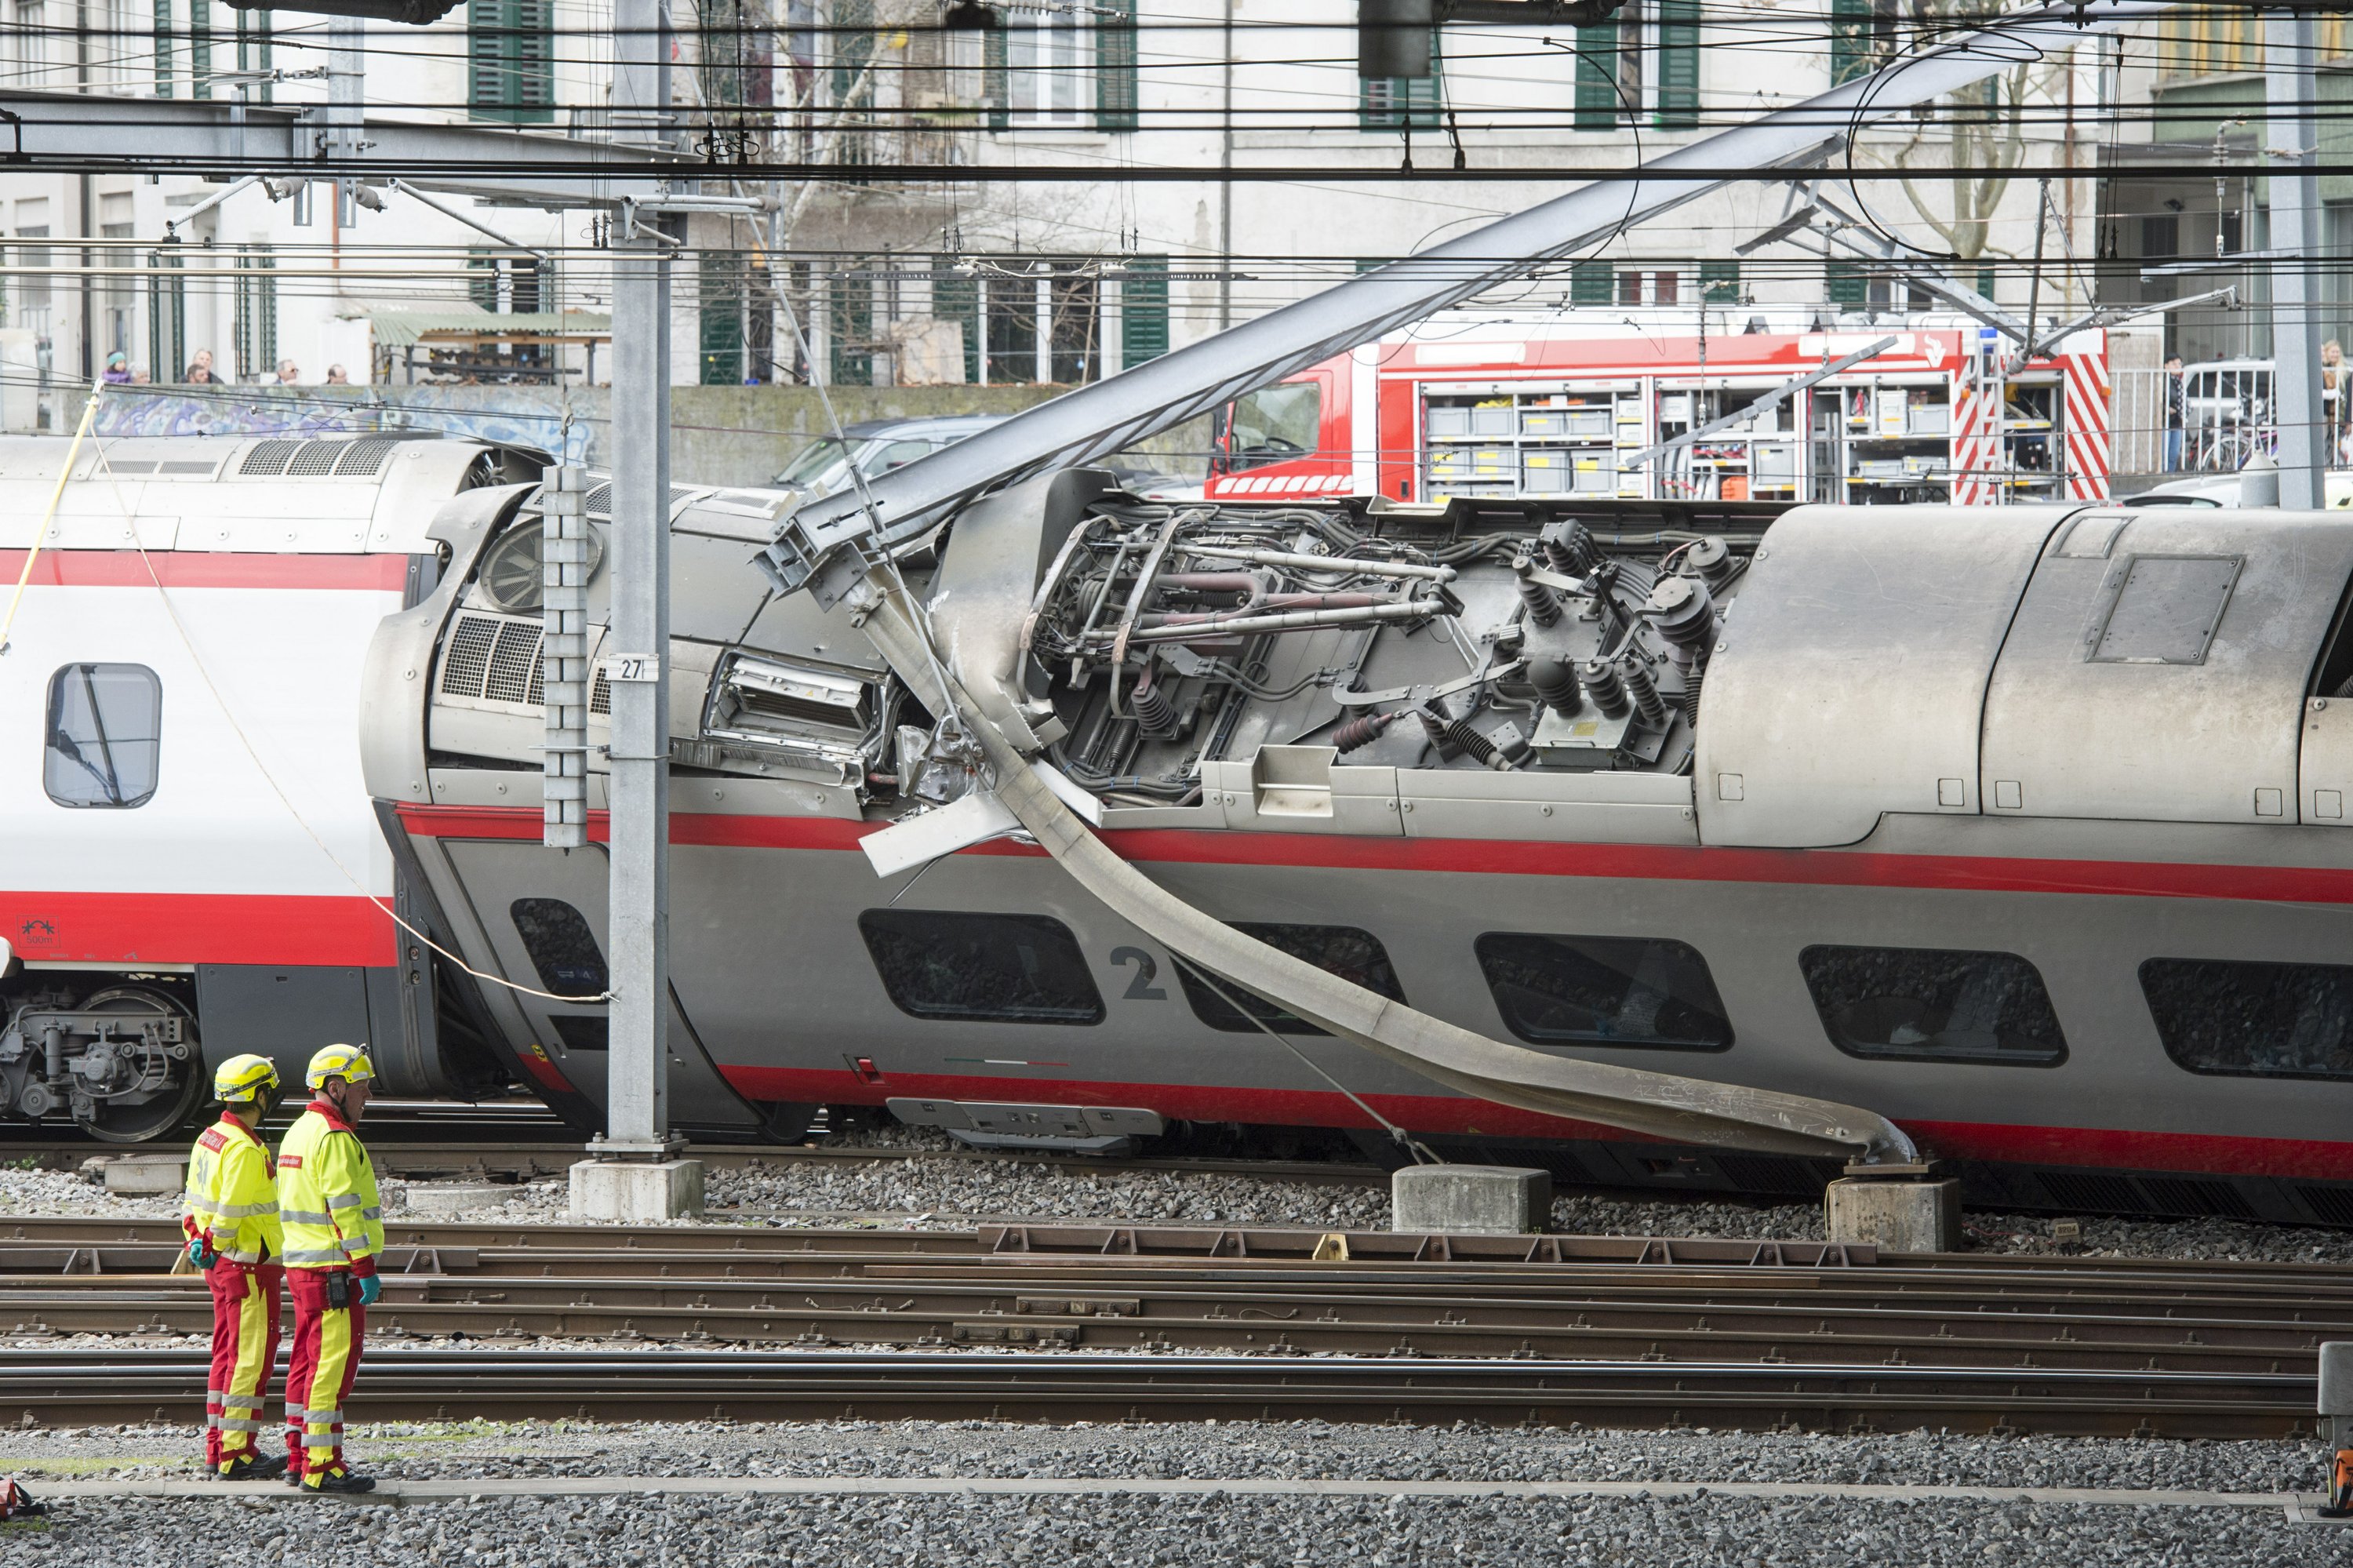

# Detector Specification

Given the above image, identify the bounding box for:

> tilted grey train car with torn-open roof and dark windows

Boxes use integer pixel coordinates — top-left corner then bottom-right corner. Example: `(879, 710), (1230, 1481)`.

(362, 473), (2353, 1224)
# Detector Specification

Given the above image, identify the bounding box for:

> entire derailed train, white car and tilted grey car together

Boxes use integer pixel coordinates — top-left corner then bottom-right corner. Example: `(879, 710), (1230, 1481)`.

(13, 438), (2353, 1222)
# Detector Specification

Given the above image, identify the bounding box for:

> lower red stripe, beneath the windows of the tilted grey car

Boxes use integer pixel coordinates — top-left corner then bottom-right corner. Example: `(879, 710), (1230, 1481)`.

(720, 1060), (2353, 1182)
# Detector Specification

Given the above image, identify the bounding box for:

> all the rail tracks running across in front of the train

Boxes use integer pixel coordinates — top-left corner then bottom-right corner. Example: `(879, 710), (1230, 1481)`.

(0, 1220), (2353, 1436)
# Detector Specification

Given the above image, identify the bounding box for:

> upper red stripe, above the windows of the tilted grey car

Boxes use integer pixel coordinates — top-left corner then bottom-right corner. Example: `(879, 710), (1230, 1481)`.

(400, 806), (2353, 904)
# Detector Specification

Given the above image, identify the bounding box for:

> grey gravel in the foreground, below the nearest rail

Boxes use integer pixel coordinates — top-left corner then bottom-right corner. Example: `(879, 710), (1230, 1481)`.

(0, 1422), (2353, 1568)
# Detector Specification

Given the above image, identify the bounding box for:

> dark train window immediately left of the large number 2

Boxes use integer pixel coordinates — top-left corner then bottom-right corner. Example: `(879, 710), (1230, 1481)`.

(859, 909), (1104, 1024)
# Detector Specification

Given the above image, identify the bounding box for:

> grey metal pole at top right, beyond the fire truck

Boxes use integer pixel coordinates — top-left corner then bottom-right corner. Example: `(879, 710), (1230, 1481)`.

(2264, 12), (2334, 508)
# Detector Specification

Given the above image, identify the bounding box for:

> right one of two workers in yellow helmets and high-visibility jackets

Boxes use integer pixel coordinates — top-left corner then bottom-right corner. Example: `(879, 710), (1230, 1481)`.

(278, 1046), (384, 1493)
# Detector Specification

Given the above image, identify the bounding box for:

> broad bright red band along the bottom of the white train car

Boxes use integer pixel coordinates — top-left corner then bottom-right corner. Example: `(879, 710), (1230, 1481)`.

(0, 890), (400, 966)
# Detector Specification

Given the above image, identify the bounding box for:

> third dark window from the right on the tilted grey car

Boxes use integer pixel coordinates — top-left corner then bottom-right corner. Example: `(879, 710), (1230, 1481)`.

(1473, 930), (1732, 1050)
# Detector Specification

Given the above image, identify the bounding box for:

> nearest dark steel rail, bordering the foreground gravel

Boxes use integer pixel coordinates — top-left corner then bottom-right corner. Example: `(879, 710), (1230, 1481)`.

(0, 1347), (2315, 1436)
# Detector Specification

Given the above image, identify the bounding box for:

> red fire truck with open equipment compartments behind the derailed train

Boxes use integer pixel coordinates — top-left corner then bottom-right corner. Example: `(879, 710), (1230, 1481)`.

(1207, 313), (2108, 506)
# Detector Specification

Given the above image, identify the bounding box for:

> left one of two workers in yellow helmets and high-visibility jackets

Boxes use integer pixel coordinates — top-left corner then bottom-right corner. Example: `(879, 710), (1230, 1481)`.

(179, 1055), (287, 1481)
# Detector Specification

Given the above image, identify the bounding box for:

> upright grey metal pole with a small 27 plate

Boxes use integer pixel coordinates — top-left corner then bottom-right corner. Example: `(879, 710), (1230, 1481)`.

(605, 0), (671, 1156)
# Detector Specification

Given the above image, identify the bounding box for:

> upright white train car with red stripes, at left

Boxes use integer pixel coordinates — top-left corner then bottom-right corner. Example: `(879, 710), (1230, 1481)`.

(0, 435), (546, 1142)
